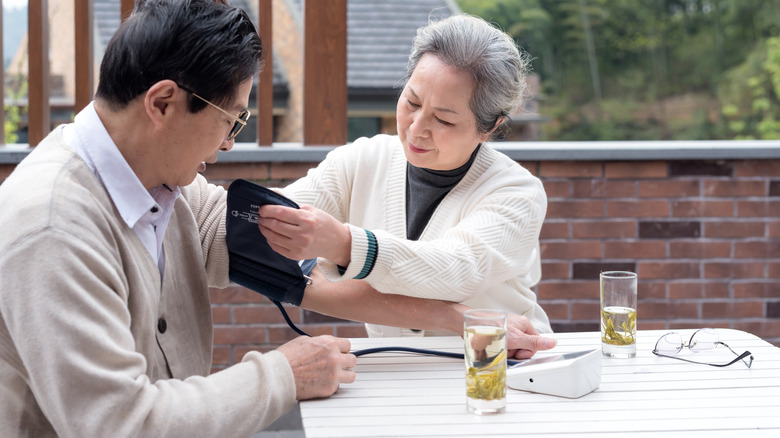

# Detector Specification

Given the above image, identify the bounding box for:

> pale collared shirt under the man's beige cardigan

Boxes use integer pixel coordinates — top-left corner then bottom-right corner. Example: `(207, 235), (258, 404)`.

(63, 102), (181, 278)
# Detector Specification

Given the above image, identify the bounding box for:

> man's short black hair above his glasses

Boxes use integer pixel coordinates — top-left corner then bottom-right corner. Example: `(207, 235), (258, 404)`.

(96, 0), (263, 112)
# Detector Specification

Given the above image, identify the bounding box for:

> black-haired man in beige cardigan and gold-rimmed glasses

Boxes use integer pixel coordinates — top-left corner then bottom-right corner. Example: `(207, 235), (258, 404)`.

(0, 0), (355, 437)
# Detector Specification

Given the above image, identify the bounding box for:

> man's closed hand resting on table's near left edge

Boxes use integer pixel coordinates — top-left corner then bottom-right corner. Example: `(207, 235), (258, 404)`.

(277, 335), (357, 400)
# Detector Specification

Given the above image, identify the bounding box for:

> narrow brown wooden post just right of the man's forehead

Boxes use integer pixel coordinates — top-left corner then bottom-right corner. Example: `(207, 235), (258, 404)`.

(256, 0), (274, 146)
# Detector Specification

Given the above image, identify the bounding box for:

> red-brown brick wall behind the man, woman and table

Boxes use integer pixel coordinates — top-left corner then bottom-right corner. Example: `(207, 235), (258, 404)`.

(0, 154), (780, 370)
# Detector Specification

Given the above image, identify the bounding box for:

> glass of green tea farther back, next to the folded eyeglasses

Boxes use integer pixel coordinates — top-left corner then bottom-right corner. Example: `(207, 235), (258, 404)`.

(599, 271), (637, 358)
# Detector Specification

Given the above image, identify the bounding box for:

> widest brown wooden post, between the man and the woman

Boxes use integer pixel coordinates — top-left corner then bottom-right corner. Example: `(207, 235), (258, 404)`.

(303, 0), (347, 145)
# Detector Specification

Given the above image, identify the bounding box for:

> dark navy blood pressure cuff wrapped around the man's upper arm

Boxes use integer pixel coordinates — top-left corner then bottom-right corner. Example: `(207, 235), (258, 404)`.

(226, 179), (316, 306)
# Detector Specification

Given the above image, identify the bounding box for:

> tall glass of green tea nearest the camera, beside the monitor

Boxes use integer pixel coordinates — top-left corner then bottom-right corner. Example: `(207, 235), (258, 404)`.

(463, 309), (507, 415)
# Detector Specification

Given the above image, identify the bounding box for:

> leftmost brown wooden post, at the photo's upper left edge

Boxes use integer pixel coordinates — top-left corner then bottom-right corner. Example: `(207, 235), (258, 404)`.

(27, 0), (51, 146)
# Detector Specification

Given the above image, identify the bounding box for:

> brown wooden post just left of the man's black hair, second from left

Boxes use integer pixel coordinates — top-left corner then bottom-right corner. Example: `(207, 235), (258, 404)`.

(74, 0), (94, 113)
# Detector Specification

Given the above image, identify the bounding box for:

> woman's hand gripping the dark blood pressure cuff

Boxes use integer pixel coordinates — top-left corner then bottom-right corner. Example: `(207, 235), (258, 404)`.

(257, 204), (352, 266)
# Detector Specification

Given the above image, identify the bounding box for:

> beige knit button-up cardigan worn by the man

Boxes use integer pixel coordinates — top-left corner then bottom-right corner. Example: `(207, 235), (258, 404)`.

(0, 129), (295, 438)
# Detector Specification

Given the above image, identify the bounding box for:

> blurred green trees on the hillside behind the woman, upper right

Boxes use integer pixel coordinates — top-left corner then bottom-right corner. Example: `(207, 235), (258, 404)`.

(459, 0), (780, 140)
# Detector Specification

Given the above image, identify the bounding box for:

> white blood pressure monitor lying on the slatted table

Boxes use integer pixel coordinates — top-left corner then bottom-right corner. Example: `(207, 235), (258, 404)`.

(506, 349), (602, 398)
